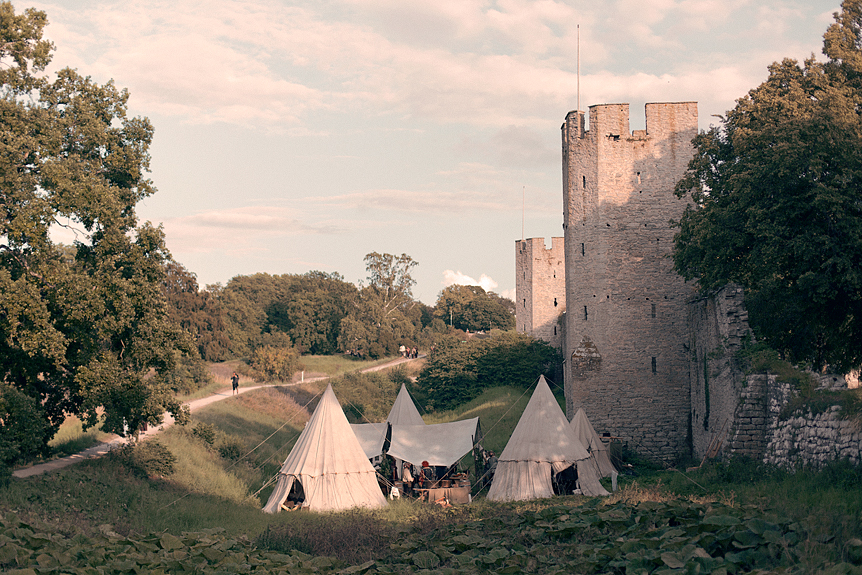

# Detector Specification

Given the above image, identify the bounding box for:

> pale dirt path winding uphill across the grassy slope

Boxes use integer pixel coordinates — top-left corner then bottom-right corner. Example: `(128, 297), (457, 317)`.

(12, 355), (425, 478)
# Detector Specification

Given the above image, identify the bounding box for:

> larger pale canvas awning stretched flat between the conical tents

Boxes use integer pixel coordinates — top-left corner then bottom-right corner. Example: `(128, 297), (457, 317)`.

(387, 417), (480, 467)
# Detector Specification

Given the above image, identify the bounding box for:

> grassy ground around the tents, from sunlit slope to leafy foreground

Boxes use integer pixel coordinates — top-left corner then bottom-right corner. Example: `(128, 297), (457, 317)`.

(5, 362), (862, 574)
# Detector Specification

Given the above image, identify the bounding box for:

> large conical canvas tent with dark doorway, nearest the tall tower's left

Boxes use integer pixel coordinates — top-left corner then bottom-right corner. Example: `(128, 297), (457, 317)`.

(488, 376), (608, 501)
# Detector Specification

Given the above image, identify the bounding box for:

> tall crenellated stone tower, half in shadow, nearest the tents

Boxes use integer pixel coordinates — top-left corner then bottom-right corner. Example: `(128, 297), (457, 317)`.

(562, 102), (697, 461)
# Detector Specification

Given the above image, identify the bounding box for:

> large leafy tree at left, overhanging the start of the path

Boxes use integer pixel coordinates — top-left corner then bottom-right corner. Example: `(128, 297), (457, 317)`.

(0, 2), (189, 463)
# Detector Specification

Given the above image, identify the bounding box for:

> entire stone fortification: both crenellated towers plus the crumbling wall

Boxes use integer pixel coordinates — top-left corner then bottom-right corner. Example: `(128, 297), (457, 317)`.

(515, 103), (862, 467)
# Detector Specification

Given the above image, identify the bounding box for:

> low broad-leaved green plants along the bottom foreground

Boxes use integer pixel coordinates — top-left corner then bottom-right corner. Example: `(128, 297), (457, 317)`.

(0, 490), (862, 575)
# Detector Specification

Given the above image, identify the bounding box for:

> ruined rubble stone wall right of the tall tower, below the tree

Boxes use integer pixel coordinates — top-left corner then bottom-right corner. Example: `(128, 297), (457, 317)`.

(689, 285), (862, 469)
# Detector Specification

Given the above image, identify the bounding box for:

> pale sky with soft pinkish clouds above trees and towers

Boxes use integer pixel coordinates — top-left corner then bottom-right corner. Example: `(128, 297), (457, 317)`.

(37, 0), (839, 305)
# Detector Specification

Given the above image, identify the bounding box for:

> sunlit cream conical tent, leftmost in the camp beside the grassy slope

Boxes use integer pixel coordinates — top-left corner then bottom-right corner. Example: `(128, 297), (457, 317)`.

(263, 385), (386, 513)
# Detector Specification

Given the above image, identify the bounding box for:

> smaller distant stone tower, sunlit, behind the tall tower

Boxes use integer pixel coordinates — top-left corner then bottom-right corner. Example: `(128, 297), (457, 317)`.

(515, 238), (566, 349)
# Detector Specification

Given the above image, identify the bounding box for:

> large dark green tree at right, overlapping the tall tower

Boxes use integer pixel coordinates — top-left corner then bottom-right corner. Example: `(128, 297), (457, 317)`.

(674, 0), (862, 369)
